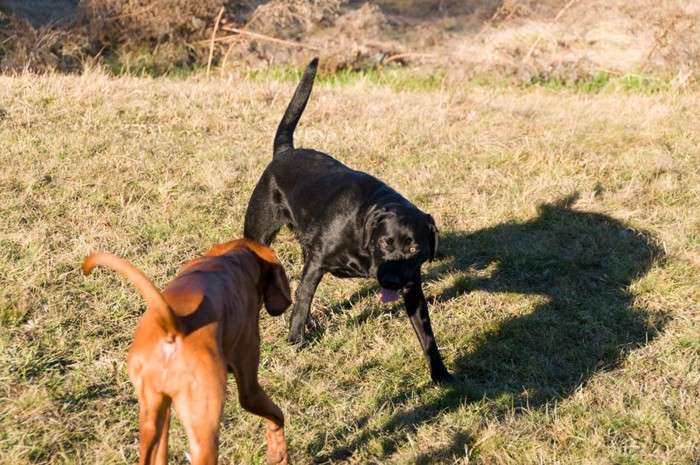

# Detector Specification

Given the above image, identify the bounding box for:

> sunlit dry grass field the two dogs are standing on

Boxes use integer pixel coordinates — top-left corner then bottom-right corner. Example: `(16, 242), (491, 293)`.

(0, 66), (700, 464)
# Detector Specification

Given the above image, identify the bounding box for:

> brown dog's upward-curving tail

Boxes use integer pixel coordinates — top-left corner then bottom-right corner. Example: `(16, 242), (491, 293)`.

(83, 252), (182, 335)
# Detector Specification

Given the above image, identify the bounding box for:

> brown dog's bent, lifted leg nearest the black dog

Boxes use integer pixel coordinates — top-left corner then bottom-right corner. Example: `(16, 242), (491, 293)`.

(232, 329), (289, 465)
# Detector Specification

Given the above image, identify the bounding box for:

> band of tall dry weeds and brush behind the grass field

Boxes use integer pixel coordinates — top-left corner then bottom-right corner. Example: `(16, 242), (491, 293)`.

(0, 0), (700, 79)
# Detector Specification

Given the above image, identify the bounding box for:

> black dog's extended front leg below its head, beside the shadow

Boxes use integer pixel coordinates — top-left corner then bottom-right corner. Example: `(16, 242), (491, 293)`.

(403, 270), (454, 384)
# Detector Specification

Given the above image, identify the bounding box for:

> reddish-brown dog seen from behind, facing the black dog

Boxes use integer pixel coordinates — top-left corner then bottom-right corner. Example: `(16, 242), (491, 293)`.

(83, 239), (291, 465)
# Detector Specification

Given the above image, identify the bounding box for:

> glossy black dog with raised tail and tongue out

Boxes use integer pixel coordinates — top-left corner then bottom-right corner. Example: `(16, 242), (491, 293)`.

(244, 59), (452, 382)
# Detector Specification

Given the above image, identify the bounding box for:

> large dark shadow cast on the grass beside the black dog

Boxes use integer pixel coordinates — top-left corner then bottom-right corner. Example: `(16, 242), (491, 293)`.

(309, 195), (666, 463)
